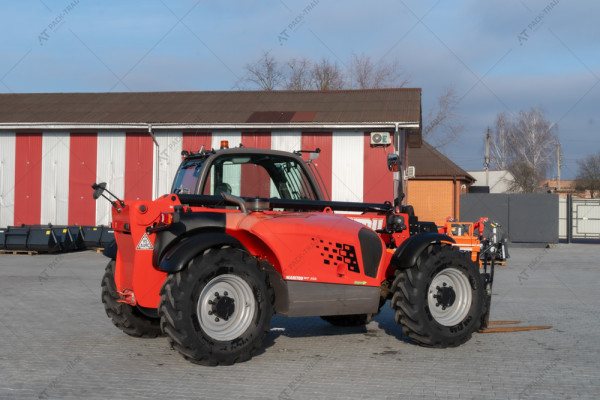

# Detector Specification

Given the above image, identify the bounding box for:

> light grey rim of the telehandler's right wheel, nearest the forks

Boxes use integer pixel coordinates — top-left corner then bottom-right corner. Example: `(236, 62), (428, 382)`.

(427, 268), (473, 326)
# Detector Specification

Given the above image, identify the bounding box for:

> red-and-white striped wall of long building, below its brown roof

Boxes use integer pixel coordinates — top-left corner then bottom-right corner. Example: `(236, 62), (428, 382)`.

(0, 130), (393, 226)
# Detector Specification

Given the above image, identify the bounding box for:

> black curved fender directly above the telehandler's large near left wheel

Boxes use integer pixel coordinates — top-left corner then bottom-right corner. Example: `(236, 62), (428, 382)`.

(158, 232), (247, 273)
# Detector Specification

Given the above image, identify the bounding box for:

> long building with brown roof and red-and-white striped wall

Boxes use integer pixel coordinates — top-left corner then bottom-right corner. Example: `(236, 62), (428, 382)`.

(0, 88), (421, 226)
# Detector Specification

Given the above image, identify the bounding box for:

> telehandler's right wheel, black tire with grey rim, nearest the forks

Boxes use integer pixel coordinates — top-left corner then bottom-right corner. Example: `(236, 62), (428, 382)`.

(390, 245), (485, 348)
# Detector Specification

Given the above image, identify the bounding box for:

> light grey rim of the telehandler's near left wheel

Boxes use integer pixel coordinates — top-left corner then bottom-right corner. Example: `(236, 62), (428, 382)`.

(197, 274), (256, 341)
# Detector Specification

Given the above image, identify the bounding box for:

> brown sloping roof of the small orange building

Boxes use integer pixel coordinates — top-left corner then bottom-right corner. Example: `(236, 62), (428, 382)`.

(408, 142), (475, 183)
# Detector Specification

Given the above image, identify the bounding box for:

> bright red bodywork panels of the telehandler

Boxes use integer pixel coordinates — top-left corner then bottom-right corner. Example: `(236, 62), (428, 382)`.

(112, 195), (409, 308)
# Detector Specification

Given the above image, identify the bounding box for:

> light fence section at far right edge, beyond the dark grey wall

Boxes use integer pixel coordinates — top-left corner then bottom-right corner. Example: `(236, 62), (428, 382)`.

(558, 196), (600, 241)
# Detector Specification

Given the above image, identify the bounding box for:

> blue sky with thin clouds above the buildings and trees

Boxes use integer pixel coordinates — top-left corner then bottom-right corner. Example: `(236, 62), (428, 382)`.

(0, 0), (600, 179)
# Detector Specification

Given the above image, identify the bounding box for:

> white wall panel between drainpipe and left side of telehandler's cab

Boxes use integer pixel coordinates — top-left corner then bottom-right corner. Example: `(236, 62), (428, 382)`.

(152, 131), (183, 197)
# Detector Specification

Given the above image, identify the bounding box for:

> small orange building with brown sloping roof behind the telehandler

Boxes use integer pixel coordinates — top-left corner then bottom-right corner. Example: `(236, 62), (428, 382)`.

(407, 142), (475, 225)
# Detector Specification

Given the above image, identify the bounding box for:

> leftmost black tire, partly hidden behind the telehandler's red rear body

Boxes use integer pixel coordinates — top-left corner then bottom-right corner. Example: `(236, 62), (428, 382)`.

(102, 260), (162, 338)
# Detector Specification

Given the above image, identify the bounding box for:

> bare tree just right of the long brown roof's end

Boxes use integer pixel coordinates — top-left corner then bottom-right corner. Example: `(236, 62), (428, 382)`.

(423, 87), (464, 148)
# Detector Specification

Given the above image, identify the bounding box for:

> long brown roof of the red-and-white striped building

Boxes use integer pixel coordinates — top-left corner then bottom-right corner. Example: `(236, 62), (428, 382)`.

(0, 88), (421, 127)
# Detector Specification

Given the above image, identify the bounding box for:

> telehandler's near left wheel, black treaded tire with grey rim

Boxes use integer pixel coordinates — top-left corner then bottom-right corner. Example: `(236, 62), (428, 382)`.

(159, 248), (274, 365)
